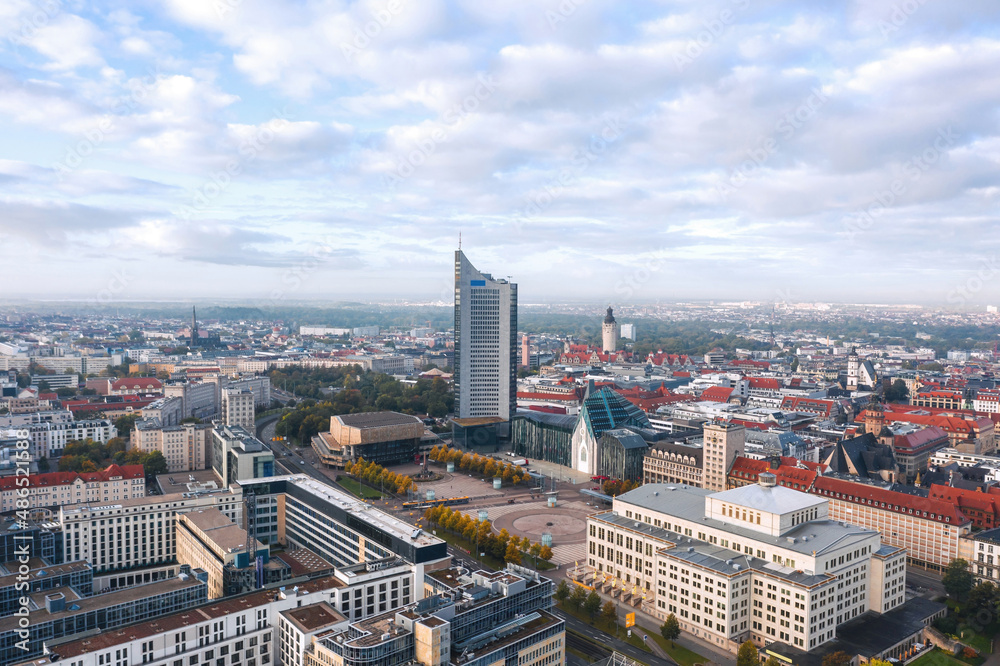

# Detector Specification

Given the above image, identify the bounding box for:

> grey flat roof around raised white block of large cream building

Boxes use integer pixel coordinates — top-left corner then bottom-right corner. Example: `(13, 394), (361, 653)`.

(601, 483), (877, 556)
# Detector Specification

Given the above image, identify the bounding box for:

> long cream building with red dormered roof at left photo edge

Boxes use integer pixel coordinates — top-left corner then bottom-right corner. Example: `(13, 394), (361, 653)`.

(0, 465), (146, 512)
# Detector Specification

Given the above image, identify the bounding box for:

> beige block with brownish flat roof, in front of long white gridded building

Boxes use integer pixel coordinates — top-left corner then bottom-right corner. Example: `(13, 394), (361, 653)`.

(176, 508), (267, 599)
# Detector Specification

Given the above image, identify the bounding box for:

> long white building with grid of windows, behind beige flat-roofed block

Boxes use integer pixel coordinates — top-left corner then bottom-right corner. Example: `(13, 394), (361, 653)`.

(59, 486), (243, 574)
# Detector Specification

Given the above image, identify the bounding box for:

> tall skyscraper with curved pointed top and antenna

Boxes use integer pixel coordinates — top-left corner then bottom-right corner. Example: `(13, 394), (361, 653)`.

(455, 250), (517, 420)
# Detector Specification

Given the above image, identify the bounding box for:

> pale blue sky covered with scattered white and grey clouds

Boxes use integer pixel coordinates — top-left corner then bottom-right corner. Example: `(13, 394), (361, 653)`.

(0, 0), (1000, 308)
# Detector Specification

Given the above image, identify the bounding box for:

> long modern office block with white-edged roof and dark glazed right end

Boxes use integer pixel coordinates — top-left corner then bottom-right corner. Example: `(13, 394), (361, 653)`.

(240, 475), (448, 588)
